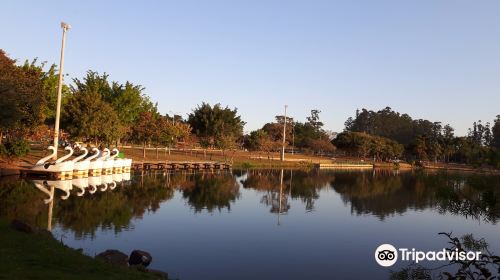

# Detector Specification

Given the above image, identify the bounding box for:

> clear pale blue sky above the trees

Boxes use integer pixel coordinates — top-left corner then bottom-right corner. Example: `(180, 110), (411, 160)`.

(0, 0), (500, 135)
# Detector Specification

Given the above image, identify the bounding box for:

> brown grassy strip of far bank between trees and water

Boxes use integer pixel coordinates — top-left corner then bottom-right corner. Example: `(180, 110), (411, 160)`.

(0, 147), (500, 177)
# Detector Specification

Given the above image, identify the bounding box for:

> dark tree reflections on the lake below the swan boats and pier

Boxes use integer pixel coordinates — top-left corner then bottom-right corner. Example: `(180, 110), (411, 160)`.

(0, 172), (240, 239)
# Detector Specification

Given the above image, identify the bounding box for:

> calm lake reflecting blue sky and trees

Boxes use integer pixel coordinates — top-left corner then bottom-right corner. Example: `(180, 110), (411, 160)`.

(0, 170), (500, 280)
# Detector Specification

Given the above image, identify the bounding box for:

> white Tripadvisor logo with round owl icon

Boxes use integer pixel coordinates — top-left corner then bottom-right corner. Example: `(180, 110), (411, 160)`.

(375, 244), (481, 267)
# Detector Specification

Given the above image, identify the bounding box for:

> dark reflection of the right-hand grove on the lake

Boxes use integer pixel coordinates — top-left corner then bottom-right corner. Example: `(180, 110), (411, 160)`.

(332, 170), (500, 224)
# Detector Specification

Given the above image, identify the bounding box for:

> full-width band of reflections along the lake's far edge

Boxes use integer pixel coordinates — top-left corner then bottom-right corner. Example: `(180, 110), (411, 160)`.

(0, 170), (500, 239)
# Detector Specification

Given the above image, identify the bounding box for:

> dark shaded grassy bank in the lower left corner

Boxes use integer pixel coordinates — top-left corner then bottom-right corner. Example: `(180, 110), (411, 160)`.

(0, 219), (161, 280)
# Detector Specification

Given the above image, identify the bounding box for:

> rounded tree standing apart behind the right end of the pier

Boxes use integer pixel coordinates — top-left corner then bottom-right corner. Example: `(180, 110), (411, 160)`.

(188, 102), (245, 149)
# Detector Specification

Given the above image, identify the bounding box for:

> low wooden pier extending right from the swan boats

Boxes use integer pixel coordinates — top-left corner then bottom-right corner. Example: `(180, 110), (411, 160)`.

(132, 161), (232, 171)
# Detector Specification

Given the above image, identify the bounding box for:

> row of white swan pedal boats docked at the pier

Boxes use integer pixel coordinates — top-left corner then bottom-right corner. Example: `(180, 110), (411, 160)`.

(27, 145), (132, 180)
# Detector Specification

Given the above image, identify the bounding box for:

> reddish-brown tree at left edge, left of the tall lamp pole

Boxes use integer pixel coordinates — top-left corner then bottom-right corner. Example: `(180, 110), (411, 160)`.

(0, 50), (46, 143)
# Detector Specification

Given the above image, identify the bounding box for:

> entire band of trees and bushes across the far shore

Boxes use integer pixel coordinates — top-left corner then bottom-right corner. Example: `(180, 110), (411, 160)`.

(0, 50), (500, 169)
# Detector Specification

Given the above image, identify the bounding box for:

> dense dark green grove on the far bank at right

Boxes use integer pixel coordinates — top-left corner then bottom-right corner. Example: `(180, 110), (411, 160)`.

(342, 107), (500, 165)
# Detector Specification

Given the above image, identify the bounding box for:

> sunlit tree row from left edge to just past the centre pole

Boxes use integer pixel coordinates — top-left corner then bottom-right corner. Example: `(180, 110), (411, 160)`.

(0, 50), (335, 158)
